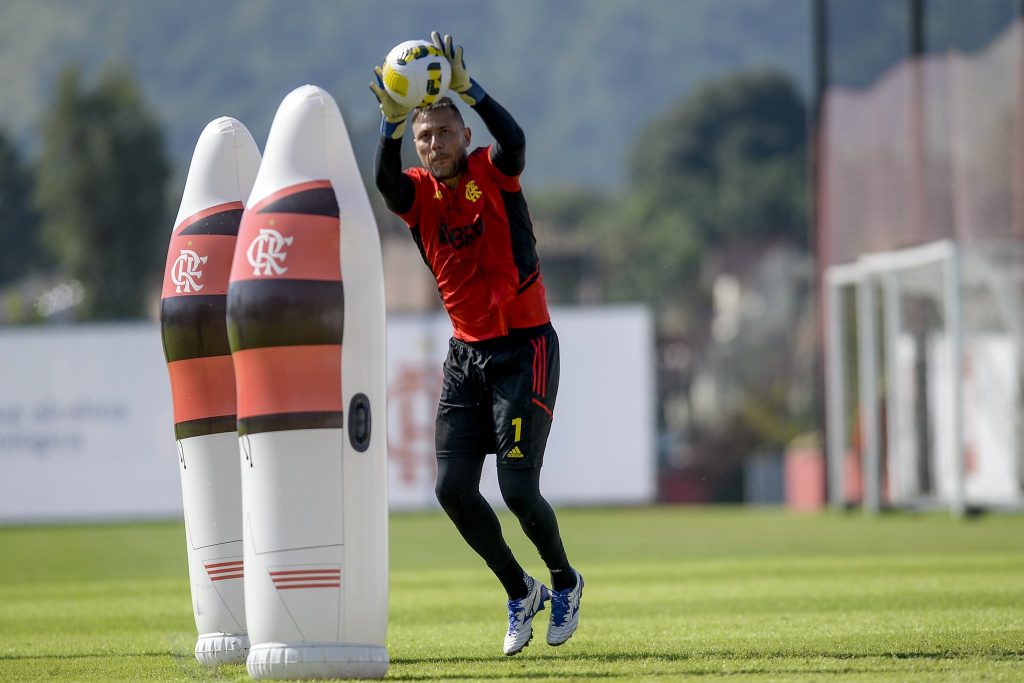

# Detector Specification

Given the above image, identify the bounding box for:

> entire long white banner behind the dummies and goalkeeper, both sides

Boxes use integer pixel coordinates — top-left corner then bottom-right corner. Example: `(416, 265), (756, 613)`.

(0, 306), (656, 523)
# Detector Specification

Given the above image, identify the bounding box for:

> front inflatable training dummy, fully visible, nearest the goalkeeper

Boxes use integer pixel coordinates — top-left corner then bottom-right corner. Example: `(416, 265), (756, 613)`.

(227, 85), (388, 678)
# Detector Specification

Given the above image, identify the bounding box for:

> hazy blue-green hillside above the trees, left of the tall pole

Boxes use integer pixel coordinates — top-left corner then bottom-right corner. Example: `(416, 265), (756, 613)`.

(0, 0), (810, 189)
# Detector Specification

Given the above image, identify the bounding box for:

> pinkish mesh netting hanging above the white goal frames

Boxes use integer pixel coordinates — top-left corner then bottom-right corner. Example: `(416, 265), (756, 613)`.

(817, 23), (1024, 267)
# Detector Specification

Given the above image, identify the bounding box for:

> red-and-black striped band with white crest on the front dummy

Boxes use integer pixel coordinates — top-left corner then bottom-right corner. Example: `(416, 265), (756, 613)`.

(227, 180), (345, 436)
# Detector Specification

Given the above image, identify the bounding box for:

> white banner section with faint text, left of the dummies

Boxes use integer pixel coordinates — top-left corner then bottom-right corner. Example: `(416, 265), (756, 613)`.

(0, 324), (181, 522)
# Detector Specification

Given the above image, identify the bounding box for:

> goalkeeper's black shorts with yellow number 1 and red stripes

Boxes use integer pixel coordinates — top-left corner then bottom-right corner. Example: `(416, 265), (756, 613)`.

(434, 324), (558, 468)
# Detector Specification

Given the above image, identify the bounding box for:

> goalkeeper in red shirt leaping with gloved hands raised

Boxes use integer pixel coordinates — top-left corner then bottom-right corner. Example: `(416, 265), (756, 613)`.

(370, 32), (584, 654)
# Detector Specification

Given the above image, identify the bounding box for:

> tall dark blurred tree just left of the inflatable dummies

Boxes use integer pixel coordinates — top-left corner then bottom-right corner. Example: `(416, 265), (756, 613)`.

(34, 68), (170, 319)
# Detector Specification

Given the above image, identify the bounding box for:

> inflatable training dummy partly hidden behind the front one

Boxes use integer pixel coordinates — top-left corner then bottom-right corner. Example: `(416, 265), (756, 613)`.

(160, 117), (260, 666)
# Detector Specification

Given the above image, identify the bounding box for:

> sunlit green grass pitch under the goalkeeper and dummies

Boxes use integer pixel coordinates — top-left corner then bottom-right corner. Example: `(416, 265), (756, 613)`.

(0, 508), (1024, 681)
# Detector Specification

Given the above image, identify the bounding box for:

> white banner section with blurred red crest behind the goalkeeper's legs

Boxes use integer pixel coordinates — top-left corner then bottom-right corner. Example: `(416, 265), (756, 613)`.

(388, 307), (656, 509)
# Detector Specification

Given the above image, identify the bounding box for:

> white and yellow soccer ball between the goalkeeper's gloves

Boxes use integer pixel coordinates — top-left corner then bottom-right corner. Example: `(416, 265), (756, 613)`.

(382, 40), (452, 106)
